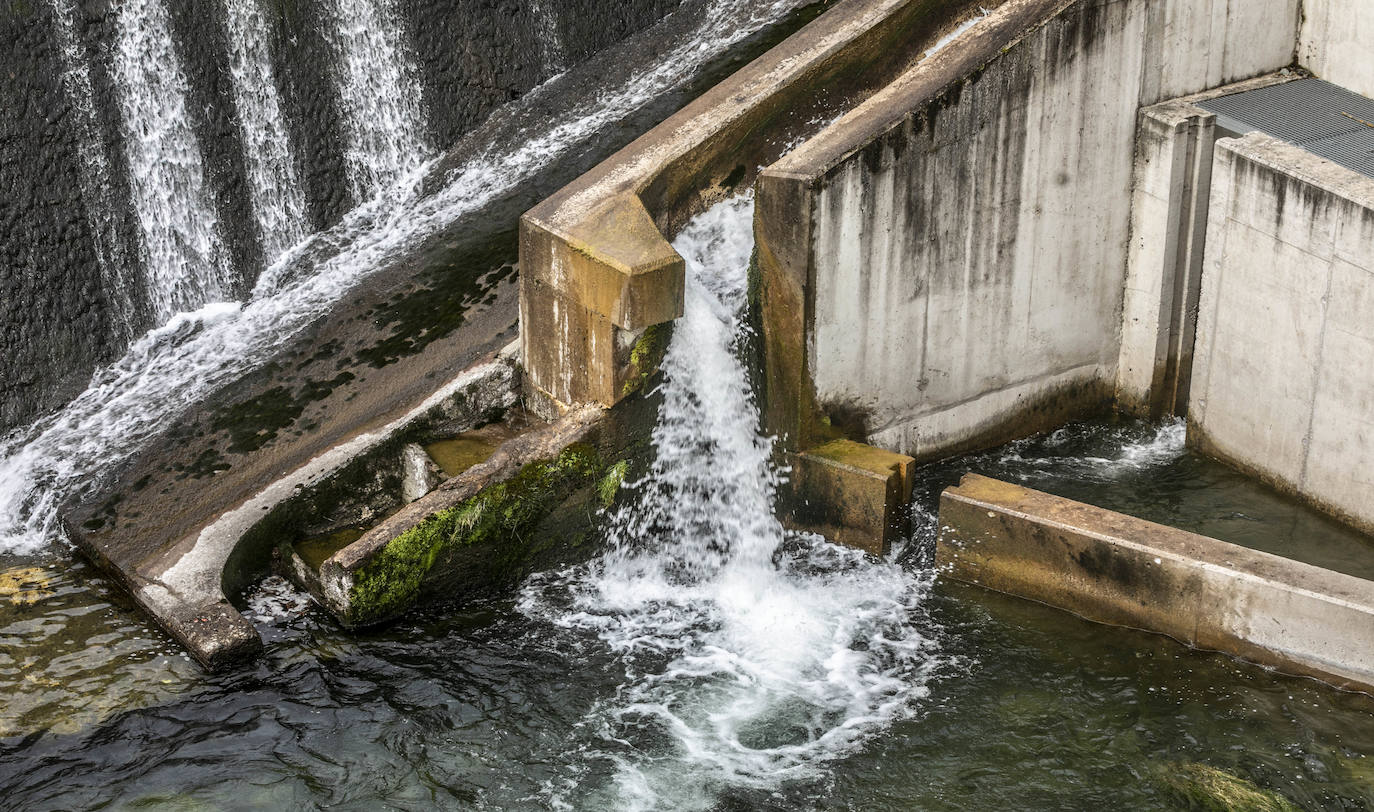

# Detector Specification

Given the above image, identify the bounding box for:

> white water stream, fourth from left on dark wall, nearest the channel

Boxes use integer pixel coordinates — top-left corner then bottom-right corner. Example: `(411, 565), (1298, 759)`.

(324, 0), (429, 202)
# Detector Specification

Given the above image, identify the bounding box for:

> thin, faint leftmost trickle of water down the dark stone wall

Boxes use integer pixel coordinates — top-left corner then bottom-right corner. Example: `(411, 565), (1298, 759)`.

(52, 0), (137, 342)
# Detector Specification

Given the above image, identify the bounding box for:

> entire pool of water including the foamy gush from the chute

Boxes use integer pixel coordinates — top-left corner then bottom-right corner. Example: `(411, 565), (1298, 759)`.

(0, 201), (1374, 811)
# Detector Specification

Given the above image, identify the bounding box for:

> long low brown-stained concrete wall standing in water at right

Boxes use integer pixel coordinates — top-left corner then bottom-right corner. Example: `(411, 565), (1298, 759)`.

(936, 474), (1374, 691)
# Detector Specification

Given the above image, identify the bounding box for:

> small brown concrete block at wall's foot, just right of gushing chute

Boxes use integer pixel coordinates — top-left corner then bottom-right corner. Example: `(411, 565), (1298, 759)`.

(791, 440), (915, 555)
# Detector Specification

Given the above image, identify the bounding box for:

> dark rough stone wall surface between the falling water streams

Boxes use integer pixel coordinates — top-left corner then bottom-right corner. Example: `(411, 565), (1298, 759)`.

(0, 0), (679, 433)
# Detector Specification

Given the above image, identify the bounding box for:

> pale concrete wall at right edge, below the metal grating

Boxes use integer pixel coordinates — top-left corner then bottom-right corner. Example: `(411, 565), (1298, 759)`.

(1189, 133), (1374, 529)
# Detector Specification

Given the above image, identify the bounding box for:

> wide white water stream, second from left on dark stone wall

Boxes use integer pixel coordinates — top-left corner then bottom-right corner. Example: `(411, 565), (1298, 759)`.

(111, 0), (236, 324)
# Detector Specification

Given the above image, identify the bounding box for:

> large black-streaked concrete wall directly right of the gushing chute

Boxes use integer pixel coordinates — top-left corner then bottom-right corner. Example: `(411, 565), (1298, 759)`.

(757, 0), (1296, 458)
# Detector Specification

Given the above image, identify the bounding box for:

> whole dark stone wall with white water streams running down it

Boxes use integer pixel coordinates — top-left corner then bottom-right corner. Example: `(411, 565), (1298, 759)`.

(0, 0), (677, 433)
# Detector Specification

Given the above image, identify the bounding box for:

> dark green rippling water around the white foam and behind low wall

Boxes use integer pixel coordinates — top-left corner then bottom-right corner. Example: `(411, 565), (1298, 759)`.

(0, 425), (1374, 809)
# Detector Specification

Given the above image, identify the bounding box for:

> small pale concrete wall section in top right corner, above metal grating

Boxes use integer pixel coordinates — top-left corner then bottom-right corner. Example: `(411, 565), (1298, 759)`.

(1297, 0), (1374, 96)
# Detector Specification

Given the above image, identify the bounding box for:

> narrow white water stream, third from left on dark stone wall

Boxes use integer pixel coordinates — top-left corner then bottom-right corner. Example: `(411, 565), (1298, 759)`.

(224, 0), (309, 265)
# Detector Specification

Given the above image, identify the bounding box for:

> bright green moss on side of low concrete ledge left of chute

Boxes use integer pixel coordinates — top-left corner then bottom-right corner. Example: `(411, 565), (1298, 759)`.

(348, 444), (612, 625)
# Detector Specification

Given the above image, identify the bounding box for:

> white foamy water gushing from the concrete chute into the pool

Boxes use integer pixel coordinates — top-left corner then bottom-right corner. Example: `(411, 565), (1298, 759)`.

(521, 199), (940, 809)
